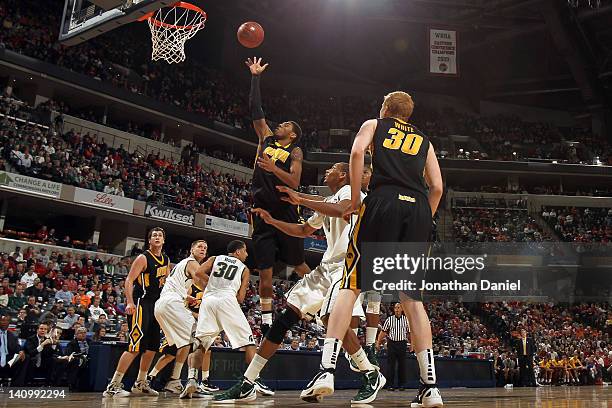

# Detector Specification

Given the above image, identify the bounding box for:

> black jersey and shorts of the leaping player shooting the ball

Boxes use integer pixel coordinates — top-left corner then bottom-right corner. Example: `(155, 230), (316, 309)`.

(251, 136), (304, 269)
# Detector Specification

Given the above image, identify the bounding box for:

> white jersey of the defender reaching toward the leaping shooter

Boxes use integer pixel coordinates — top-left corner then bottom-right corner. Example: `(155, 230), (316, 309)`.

(306, 184), (365, 263)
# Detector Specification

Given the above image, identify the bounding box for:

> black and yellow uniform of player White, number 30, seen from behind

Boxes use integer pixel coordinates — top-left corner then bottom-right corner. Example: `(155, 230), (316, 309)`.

(342, 118), (432, 298)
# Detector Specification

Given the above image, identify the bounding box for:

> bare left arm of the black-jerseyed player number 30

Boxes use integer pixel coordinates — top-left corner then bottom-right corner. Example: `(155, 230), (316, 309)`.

(344, 119), (377, 219)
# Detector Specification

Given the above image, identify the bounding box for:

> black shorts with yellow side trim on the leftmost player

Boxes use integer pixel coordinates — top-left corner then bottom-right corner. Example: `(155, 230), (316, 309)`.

(128, 299), (161, 352)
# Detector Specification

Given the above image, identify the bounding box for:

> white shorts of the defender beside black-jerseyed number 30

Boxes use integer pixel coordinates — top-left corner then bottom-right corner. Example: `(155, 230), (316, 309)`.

(286, 261), (365, 320)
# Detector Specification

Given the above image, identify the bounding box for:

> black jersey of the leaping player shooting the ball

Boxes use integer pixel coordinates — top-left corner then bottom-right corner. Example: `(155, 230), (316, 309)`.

(251, 136), (298, 211)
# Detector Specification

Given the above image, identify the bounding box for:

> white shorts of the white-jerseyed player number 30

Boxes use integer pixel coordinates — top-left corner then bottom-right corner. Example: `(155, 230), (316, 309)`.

(195, 294), (255, 349)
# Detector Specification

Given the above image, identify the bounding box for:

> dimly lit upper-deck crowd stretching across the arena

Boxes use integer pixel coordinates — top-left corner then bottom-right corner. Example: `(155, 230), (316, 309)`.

(0, 0), (612, 164)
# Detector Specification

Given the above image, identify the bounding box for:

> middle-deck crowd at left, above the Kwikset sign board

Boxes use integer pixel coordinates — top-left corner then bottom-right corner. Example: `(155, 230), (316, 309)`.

(0, 95), (251, 222)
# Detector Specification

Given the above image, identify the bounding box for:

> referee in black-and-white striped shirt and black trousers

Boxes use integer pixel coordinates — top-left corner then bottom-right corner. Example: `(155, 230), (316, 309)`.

(376, 303), (410, 391)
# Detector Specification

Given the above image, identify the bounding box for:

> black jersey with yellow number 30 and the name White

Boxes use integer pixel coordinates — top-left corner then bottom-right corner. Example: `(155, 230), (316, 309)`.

(370, 118), (429, 197)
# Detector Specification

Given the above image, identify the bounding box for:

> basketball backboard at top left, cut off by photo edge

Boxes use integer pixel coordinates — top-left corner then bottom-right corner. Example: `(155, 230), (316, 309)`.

(59, 0), (177, 45)
